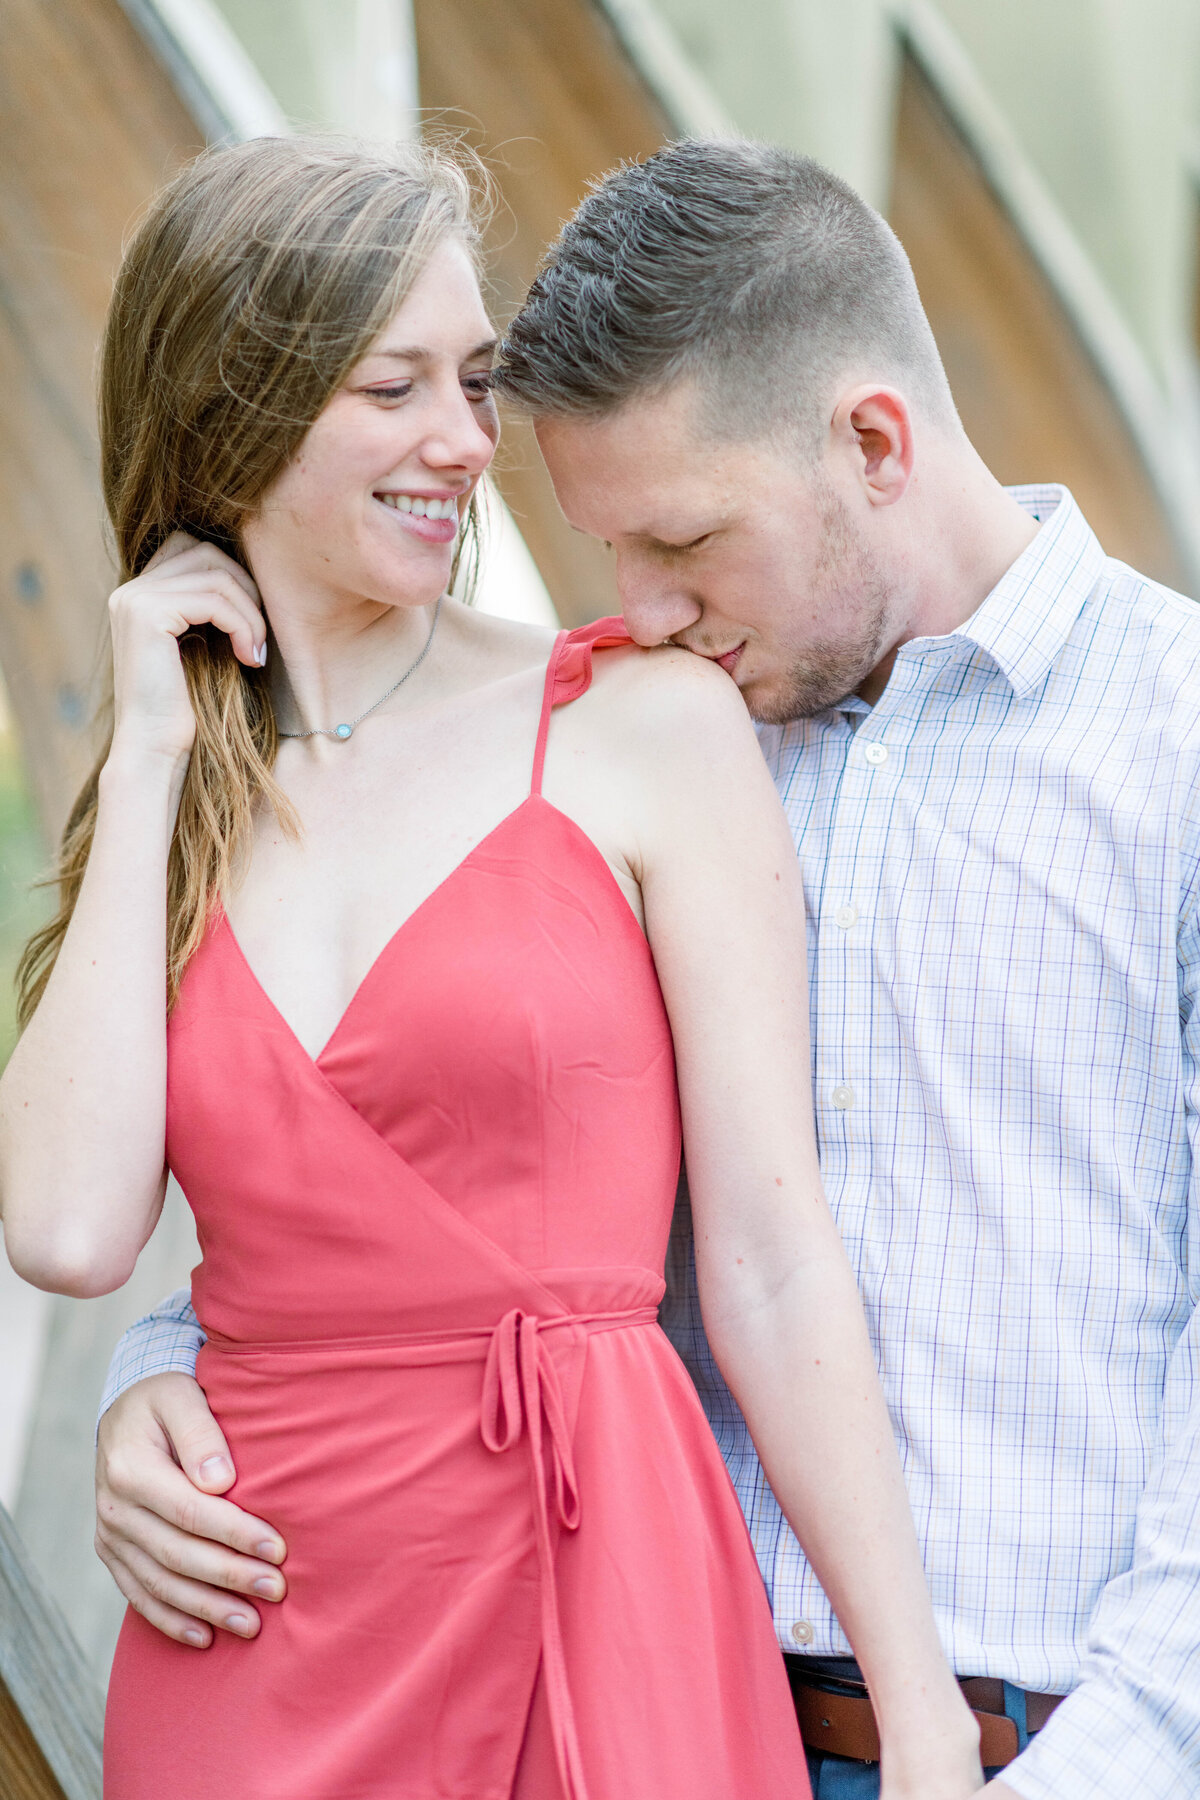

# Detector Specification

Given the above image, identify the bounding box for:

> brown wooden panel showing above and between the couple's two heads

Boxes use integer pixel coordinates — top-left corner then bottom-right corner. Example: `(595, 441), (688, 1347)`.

(414, 0), (669, 625)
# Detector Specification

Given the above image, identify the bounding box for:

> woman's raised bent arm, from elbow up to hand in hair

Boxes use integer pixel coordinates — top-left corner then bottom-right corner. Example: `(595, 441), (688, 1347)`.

(0, 533), (266, 1294)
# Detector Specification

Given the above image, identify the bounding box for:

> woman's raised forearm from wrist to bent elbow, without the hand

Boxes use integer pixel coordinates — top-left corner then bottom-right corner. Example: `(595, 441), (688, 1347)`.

(0, 749), (185, 1294)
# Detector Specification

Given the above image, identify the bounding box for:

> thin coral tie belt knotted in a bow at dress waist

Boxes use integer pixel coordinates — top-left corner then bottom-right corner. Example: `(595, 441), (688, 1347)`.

(480, 1307), (658, 1800)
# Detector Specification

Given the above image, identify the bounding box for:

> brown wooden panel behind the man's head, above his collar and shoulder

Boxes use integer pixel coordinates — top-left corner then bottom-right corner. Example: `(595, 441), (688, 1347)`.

(889, 58), (1187, 590)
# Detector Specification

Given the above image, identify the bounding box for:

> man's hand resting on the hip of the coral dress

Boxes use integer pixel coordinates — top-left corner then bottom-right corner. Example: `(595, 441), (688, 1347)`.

(95, 1375), (286, 1649)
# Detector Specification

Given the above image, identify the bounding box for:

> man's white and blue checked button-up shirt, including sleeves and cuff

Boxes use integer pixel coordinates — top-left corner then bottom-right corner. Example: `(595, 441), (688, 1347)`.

(103, 488), (1200, 1800)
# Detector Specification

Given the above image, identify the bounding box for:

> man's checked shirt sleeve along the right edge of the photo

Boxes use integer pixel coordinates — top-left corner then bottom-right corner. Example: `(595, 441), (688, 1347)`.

(1002, 892), (1200, 1800)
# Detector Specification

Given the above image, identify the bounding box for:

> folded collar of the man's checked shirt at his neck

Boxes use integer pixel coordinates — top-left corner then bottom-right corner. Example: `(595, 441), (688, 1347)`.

(952, 482), (1106, 697)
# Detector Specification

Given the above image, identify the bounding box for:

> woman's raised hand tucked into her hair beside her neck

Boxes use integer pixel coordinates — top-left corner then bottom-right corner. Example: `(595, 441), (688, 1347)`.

(108, 531), (266, 763)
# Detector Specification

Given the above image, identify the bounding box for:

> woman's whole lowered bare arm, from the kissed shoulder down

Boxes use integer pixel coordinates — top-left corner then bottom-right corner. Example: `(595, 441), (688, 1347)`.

(611, 655), (982, 1800)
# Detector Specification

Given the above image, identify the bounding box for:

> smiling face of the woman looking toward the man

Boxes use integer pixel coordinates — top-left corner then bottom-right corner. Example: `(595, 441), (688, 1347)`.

(243, 239), (500, 610)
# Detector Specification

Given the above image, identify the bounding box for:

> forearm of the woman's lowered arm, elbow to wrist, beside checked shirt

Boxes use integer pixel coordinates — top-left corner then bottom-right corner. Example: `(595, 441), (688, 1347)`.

(698, 1220), (973, 1769)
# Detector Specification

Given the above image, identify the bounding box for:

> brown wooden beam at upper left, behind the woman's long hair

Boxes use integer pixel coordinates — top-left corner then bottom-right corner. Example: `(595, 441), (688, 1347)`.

(0, 0), (203, 839)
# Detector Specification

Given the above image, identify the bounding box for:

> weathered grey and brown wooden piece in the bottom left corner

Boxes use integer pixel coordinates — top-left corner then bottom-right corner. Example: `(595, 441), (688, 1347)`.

(0, 1507), (103, 1800)
